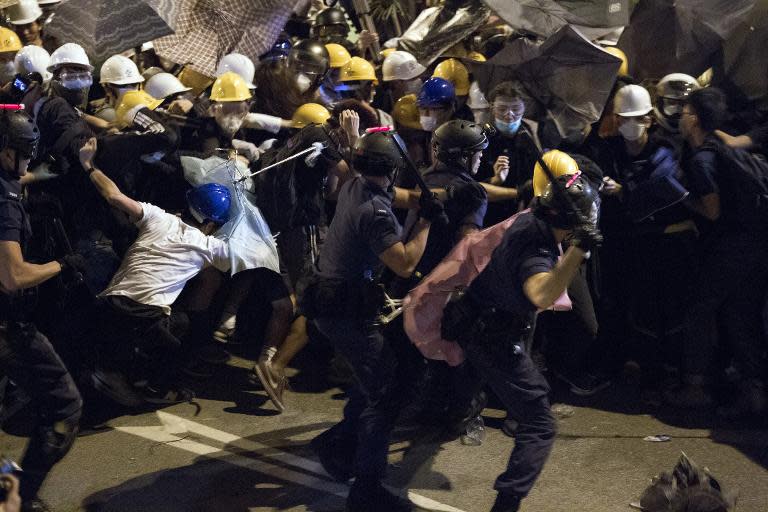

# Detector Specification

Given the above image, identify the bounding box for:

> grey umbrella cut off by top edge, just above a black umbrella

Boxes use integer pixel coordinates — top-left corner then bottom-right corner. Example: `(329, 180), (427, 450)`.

(483, 0), (630, 40)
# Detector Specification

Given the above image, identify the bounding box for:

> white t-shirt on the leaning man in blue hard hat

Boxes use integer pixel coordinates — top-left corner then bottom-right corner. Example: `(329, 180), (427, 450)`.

(101, 203), (230, 313)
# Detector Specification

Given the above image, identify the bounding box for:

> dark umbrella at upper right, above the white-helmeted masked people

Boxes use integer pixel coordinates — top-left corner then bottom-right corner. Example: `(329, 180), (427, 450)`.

(618, 0), (756, 80)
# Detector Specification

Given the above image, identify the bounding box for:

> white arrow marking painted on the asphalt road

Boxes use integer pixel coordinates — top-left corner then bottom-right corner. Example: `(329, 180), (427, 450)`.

(115, 411), (464, 512)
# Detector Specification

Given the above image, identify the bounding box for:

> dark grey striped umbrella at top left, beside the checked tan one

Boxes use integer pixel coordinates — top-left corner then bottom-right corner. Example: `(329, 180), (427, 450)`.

(45, 0), (178, 64)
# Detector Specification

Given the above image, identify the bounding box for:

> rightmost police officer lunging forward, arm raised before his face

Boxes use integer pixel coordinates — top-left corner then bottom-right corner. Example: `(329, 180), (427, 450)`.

(442, 175), (602, 512)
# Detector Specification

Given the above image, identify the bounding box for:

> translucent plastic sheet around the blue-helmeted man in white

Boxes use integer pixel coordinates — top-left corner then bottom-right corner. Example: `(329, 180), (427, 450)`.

(181, 156), (280, 275)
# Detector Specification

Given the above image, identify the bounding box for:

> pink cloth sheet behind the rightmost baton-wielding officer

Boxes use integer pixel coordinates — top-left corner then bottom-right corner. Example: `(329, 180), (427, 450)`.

(403, 213), (572, 366)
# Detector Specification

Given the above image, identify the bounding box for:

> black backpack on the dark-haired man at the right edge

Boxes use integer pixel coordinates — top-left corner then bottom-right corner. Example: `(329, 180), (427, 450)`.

(702, 140), (768, 224)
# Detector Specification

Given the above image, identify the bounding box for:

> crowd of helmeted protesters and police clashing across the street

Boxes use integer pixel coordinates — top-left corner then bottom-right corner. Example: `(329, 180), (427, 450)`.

(0, 0), (768, 512)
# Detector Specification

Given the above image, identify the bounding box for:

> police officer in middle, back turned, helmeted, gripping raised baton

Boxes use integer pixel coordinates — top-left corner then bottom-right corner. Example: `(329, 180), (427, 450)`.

(300, 132), (443, 512)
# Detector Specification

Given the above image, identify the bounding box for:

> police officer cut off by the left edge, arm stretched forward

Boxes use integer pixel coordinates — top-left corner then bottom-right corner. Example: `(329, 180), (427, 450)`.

(0, 112), (84, 510)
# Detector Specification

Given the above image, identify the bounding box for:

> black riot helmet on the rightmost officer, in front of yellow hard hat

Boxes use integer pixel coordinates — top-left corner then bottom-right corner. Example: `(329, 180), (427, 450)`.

(533, 172), (598, 229)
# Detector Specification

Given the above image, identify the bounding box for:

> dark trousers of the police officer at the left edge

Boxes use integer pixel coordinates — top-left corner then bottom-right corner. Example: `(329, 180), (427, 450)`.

(0, 322), (83, 500)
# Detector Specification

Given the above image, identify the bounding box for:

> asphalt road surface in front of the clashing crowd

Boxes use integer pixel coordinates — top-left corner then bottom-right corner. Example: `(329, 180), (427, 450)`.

(0, 355), (768, 512)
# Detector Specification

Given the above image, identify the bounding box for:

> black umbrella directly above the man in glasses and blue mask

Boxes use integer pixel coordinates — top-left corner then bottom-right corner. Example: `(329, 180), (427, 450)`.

(470, 25), (621, 140)
